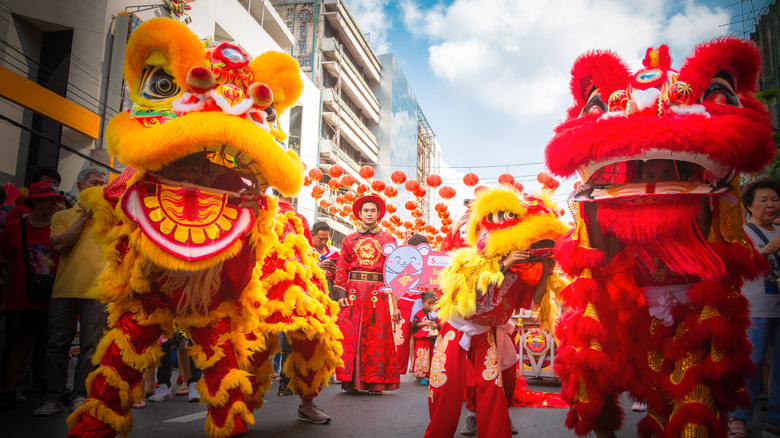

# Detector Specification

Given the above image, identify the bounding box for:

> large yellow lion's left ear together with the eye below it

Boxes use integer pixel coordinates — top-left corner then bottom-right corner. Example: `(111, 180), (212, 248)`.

(124, 18), (206, 106)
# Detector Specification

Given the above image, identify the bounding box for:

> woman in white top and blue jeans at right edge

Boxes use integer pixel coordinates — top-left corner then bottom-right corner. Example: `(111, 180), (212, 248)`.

(729, 177), (780, 438)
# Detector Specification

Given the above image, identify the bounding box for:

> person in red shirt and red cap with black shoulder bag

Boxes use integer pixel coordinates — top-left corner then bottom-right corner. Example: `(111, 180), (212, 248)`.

(0, 182), (65, 410)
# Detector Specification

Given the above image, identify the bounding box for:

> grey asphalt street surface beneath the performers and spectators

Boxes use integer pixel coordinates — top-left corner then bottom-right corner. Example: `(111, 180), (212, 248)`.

(0, 375), (766, 438)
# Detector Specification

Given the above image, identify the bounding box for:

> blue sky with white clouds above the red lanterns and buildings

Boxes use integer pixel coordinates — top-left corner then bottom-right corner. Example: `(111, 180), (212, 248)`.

(345, 0), (769, 209)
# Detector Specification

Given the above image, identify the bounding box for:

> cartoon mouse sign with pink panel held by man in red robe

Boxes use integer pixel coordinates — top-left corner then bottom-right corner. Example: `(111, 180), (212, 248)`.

(382, 243), (450, 297)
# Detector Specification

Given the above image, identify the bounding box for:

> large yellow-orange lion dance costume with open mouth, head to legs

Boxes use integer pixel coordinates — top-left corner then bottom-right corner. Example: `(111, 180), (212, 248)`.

(69, 19), (341, 437)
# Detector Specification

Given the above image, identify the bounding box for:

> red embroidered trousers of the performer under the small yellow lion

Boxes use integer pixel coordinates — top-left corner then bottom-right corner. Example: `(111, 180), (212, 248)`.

(425, 323), (514, 438)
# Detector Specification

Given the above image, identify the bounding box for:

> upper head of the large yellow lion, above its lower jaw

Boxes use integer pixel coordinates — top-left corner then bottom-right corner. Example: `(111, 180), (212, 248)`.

(106, 18), (303, 194)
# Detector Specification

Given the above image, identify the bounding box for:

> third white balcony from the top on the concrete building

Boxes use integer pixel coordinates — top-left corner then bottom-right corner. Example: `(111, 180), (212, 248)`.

(322, 88), (379, 163)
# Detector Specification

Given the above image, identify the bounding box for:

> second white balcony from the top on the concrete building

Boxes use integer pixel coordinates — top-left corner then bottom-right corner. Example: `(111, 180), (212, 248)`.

(322, 38), (379, 123)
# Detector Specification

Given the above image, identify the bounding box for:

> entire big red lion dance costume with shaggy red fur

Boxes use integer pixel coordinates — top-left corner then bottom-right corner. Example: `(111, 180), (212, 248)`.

(546, 38), (775, 437)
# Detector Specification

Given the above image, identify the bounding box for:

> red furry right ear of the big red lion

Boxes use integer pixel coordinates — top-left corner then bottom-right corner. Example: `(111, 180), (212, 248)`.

(680, 37), (761, 100)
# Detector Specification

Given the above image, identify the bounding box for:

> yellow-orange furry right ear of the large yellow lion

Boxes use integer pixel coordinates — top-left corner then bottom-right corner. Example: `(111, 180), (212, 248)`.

(249, 52), (303, 113)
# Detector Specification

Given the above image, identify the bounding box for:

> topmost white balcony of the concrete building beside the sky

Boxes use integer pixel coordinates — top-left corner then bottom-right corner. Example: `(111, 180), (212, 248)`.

(323, 0), (381, 83)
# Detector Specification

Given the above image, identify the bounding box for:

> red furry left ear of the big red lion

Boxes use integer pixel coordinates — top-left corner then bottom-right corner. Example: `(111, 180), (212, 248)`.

(568, 50), (631, 118)
